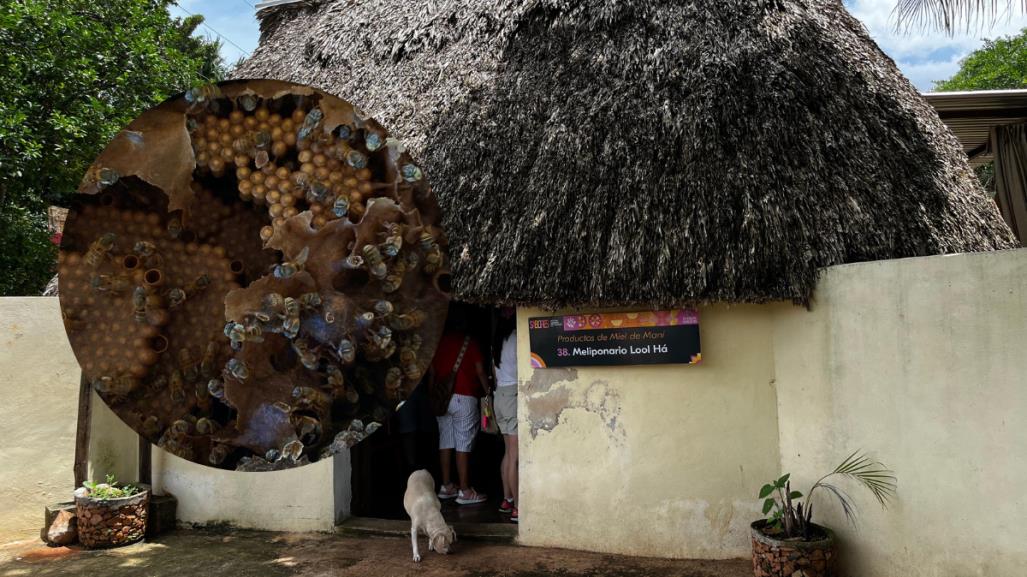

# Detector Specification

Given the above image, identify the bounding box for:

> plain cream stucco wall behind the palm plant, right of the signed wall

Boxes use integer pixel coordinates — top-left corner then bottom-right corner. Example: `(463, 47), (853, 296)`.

(773, 249), (1027, 577)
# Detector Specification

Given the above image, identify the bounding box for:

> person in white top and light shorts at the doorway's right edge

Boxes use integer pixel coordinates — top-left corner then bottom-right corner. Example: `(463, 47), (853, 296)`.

(492, 308), (519, 523)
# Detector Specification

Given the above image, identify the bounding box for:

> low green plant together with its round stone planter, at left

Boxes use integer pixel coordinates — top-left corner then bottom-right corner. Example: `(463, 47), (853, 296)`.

(75, 474), (150, 548)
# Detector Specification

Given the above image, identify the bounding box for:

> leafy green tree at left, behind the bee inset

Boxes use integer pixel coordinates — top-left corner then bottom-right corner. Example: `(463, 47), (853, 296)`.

(0, 0), (224, 295)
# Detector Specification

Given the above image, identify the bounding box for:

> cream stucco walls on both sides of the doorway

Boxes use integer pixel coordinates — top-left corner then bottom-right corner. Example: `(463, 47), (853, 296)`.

(0, 249), (1027, 577)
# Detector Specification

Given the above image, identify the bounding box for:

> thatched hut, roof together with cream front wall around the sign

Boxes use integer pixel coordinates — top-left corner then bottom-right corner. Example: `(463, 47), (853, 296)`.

(235, 0), (1016, 557)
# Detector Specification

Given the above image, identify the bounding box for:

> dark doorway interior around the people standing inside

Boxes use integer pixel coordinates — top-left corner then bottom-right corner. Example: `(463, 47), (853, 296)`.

(350, 303), (509, 523)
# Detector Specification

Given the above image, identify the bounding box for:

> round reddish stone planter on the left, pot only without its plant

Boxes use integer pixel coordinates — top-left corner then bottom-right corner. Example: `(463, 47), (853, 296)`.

(75, 486), (150, 549)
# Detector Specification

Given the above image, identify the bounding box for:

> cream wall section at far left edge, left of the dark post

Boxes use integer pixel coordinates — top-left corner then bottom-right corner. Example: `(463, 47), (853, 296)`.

(0, 298), (79, 542)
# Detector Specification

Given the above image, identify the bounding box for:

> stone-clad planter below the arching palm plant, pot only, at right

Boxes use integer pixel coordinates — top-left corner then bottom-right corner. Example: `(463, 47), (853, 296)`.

(752, 520), (836, 577)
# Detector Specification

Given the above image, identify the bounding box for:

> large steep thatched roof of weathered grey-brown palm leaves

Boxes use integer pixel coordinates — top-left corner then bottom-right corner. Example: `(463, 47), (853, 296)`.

(235, 0), (1016, 306)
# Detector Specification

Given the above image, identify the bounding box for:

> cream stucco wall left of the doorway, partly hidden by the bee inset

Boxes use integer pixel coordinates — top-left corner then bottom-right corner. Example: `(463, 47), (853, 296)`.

(0, 298), (350, 540)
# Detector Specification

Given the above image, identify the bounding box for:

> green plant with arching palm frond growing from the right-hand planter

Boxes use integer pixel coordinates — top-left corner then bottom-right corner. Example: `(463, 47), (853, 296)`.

(760, 451), (897, 541)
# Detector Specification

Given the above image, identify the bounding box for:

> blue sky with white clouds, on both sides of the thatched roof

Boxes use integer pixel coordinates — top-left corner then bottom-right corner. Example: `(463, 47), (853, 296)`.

(170, 0), (1027, 91)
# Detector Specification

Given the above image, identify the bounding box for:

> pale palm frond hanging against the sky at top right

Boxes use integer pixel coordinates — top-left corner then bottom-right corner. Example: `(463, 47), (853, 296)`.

(895, 0), (1027, 34)
